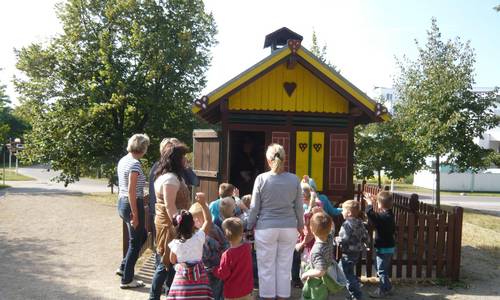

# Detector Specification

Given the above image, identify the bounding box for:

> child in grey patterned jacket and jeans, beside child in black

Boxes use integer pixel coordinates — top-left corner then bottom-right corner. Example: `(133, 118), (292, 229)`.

(336, 200), (368, 299)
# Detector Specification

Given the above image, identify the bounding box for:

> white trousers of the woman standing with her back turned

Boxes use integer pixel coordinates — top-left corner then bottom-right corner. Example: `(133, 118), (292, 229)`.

(255, 228), (298, 298)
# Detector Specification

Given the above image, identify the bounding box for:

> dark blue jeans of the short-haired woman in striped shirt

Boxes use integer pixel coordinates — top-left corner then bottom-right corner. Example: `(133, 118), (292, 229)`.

(118, 197), (146, 284)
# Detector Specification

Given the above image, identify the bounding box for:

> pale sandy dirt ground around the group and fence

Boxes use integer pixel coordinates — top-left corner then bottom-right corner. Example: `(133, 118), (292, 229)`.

(0, 188), (500, 300)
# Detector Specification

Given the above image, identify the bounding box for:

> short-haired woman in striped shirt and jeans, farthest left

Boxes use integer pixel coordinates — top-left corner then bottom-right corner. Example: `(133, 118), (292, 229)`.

(116, 134), (149, 289)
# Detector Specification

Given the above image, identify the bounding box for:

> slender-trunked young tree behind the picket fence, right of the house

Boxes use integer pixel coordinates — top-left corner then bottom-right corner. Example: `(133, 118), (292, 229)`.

(395, 19), (498, 207)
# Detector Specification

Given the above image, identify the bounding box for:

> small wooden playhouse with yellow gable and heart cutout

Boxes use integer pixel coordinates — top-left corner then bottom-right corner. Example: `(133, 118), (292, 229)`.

(193, 27), (389, 201)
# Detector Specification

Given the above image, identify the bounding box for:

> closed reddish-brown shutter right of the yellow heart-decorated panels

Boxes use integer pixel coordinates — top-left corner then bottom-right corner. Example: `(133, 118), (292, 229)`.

(328, 133), (348, 191)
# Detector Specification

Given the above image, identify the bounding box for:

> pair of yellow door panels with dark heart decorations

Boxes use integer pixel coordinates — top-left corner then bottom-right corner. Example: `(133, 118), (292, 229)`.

(295, 131), (325, 191)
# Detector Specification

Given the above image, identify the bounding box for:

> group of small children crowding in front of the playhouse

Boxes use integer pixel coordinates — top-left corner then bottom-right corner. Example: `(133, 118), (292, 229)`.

(163, 178), (395, 299)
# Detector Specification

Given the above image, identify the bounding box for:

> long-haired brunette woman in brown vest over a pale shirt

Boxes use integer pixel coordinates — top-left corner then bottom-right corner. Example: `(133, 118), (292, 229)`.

(150, 138), (191, 300)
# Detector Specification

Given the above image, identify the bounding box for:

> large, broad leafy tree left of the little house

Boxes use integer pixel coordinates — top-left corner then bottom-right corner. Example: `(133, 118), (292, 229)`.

(15, 0), (216, 184)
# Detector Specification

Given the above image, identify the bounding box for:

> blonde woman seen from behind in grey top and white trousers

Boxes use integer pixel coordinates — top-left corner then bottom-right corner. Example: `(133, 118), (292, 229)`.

(248, 144), (304, 299)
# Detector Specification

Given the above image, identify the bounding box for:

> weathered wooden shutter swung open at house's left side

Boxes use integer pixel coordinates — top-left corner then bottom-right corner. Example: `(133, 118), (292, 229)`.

(193, 129), (220, 202)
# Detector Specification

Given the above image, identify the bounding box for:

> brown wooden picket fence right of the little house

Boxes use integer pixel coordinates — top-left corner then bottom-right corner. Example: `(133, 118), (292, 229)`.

(334, 184), (463, 280)
